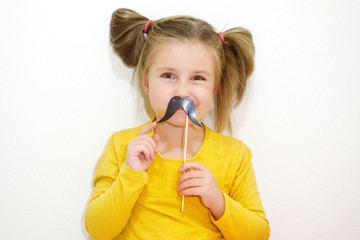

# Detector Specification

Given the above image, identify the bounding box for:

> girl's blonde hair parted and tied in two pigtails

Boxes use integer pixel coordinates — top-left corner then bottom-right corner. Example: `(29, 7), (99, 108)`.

(110, 8), (255, 133)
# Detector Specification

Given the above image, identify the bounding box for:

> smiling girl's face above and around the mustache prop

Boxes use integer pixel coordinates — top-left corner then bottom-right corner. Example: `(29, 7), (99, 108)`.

(143, 41), (217, 127)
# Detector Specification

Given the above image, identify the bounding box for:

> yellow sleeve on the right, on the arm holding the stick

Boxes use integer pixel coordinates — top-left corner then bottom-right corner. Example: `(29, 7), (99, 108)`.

(212, 145), (270, 240)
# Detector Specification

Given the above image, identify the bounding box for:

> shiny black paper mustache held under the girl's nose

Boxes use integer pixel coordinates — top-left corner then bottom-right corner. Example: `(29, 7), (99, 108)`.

(157, 96), (204, 128)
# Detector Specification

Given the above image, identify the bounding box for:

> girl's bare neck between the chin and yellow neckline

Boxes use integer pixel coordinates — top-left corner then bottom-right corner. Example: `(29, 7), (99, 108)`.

(155, 122), (205, 159)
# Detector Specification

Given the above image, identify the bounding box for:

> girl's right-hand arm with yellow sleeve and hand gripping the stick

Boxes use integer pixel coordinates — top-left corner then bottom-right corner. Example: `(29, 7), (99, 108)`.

(178, 144), (270, 240)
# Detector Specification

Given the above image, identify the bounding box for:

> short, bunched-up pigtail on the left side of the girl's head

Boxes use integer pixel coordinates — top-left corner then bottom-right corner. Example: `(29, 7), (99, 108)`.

(110, 8), (150, 67)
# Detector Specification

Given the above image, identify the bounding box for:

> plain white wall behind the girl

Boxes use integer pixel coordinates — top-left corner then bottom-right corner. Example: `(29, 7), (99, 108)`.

(0, 0), (360, 240)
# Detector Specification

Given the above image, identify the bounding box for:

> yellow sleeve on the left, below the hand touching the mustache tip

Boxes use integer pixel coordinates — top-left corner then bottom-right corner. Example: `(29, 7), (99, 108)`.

(85, 134), (148, 239)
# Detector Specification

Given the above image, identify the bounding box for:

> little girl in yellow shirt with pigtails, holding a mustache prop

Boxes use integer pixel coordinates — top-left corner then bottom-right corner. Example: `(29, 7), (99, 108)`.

(85, 9), (269, 240)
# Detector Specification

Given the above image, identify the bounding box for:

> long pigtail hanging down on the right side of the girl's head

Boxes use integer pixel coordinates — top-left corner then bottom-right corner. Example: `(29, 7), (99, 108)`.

(215, 27), (255, 133)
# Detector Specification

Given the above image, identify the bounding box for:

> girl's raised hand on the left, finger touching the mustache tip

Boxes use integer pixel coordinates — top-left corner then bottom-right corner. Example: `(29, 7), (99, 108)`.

(125, 122), (159, 171)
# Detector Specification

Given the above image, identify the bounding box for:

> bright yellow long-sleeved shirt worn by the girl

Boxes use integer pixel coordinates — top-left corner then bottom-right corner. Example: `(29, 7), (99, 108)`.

(85, 122), (270, 240)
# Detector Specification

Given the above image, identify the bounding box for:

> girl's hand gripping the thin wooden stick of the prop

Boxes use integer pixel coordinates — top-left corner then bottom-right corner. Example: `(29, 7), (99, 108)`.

(177, 161), (225, 220)
